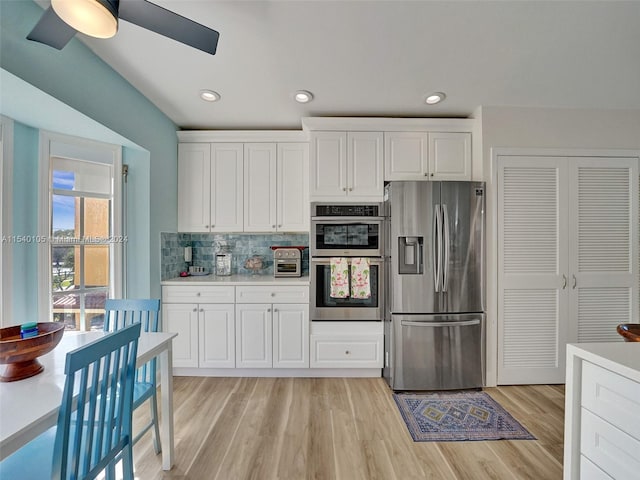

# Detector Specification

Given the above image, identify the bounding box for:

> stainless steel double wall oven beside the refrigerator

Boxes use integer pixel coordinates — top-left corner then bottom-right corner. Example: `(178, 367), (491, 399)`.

(309, 203), (384, 321)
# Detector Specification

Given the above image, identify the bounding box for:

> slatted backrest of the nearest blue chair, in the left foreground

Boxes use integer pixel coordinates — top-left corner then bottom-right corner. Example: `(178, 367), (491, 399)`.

(53, 324), (140, 479)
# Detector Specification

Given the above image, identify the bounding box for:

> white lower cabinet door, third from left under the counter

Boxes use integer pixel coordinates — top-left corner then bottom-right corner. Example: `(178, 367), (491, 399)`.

(236, 303), (273, 368)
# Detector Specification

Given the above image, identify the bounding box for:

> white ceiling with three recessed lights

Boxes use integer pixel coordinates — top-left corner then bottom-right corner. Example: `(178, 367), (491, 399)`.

(40, 0), (640, 129)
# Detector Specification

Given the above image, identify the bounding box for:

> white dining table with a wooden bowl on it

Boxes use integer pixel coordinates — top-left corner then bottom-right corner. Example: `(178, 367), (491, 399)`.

(0, 331), (177, 470)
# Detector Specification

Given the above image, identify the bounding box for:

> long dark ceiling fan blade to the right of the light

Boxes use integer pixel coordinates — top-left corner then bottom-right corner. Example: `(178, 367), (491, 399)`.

(118, 0), (219, 55)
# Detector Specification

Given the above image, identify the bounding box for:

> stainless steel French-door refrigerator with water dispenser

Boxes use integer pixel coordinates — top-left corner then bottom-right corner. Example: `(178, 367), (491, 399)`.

(383, 181), (485, 390)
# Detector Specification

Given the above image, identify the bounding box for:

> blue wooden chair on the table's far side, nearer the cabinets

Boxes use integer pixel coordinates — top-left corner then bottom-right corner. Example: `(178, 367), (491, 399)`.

(104, 298), (161, 454)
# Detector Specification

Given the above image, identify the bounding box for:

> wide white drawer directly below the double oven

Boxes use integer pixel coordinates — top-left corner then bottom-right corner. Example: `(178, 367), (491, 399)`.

(311, 335), (382, 368)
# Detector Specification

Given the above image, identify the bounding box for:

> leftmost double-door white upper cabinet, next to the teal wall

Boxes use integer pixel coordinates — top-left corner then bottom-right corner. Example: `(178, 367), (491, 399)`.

(178, 143), (243, 232)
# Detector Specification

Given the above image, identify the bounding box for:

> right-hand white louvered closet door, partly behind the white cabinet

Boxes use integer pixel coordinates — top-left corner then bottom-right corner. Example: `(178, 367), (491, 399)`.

(569, 157), (638, 342)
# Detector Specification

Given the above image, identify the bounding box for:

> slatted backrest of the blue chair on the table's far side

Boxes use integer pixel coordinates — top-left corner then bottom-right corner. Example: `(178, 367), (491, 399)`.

(104, 298), (160, 385)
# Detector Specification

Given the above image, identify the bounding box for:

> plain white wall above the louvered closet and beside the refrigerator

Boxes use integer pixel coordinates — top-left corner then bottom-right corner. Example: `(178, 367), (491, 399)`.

(474, 107), (640, 385)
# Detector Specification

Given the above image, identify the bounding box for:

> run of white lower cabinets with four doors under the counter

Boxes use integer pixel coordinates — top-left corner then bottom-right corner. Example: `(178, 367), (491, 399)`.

(162, 285), (309, 369)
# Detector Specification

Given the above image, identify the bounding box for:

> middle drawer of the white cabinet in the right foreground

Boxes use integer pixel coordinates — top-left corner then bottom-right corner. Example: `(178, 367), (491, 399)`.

(580, 408), (640, 478)
